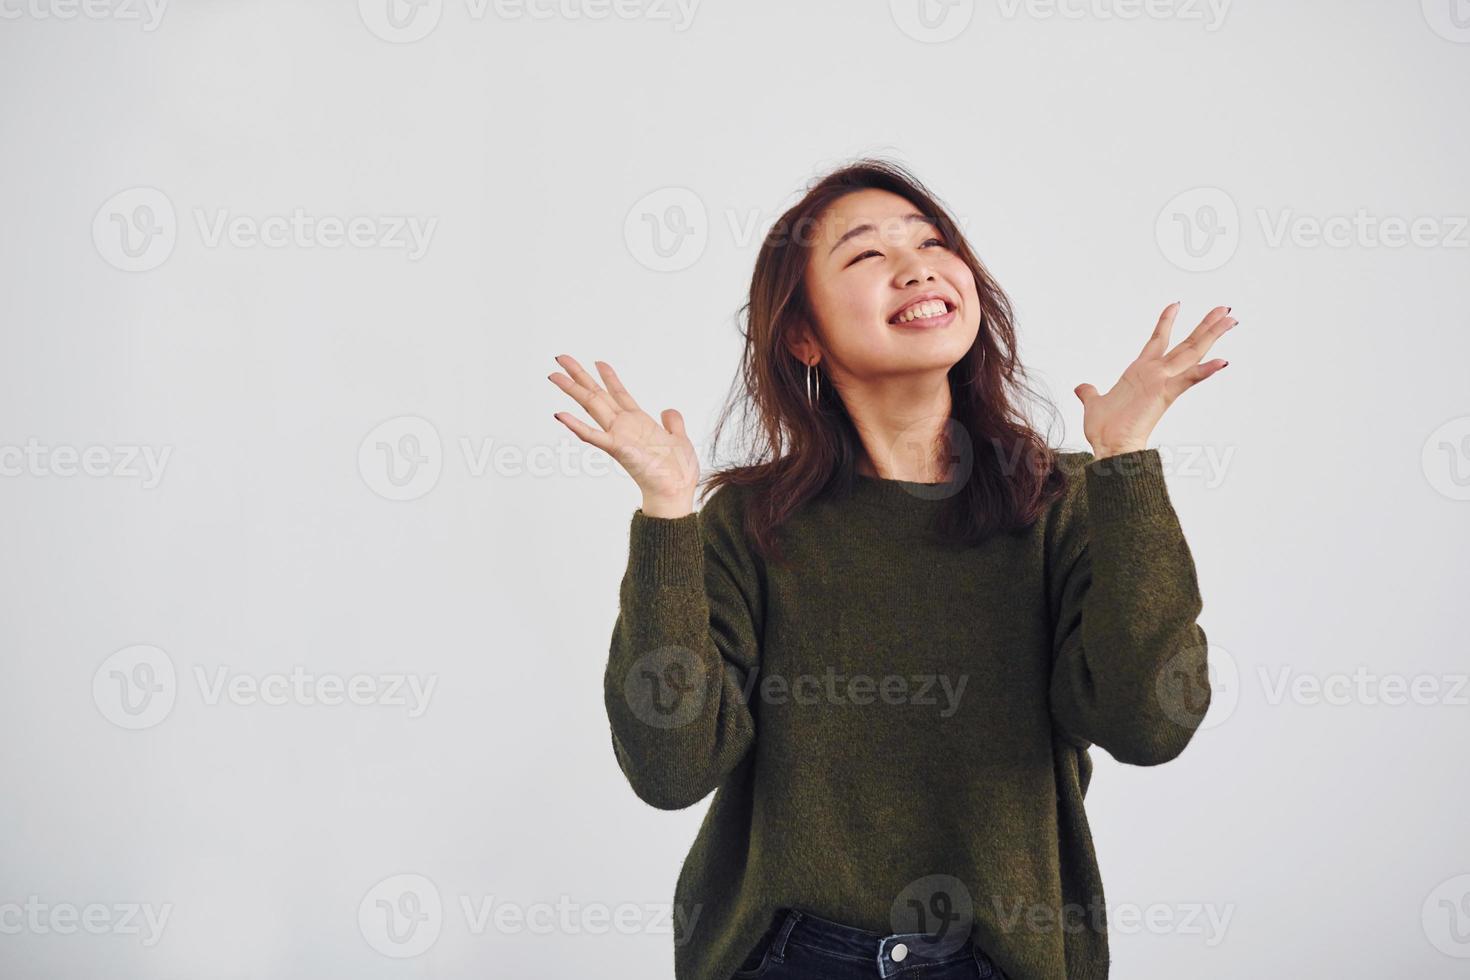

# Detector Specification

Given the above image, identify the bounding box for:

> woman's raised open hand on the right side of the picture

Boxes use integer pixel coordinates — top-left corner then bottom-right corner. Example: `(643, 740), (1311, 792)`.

(1073, 303), (1239, 458)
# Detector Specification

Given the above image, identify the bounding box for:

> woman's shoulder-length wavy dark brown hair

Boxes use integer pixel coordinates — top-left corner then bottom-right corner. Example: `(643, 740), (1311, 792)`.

(704, 157), (1064, 560)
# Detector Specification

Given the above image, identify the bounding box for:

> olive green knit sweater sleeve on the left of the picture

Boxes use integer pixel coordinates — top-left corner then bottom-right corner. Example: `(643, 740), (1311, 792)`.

(603, 485), (763, 810)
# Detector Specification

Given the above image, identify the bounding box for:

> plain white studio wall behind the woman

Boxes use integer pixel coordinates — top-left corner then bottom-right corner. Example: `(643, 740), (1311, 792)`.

(0, 0), (1470, 980)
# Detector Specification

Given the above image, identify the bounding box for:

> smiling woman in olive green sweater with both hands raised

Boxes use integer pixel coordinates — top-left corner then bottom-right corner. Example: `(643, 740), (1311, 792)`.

(550, 160), (1236, 980)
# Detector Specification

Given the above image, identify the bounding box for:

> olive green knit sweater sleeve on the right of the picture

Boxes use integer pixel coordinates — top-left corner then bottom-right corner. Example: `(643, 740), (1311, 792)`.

(1048, 450), (1210, 765)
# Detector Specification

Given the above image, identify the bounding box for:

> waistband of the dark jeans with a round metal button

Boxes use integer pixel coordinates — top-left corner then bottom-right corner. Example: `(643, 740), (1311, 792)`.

(770, 908), (995, 977)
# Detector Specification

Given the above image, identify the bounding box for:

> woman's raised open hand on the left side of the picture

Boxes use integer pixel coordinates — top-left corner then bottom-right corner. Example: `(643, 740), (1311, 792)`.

(547, 354), (700, 517)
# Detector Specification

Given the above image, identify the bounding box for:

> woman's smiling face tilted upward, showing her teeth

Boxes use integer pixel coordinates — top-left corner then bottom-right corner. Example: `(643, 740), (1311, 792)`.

(798, 188), (980, 382)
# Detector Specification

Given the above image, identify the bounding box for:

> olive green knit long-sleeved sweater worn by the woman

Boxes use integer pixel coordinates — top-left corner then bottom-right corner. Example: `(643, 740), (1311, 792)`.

(604, 450), (1210, 980)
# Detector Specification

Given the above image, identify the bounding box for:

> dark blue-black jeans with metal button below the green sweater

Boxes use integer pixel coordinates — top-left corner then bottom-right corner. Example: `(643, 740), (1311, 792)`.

(731, 908), (1005, 980)
